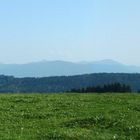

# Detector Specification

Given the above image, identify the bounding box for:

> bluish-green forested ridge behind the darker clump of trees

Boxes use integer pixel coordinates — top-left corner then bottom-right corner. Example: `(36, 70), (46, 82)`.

(0, 73), (140, 93)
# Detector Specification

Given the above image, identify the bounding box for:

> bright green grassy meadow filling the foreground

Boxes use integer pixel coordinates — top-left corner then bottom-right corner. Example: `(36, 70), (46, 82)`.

(0, 94), (140, 140)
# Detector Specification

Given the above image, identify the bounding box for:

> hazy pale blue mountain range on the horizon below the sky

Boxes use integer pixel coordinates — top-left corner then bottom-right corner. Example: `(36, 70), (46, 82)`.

(0, 60), (140, 77)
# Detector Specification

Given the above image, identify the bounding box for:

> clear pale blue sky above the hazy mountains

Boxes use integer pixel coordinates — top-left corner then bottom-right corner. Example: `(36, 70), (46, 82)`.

(0, 0), (140, 66)
